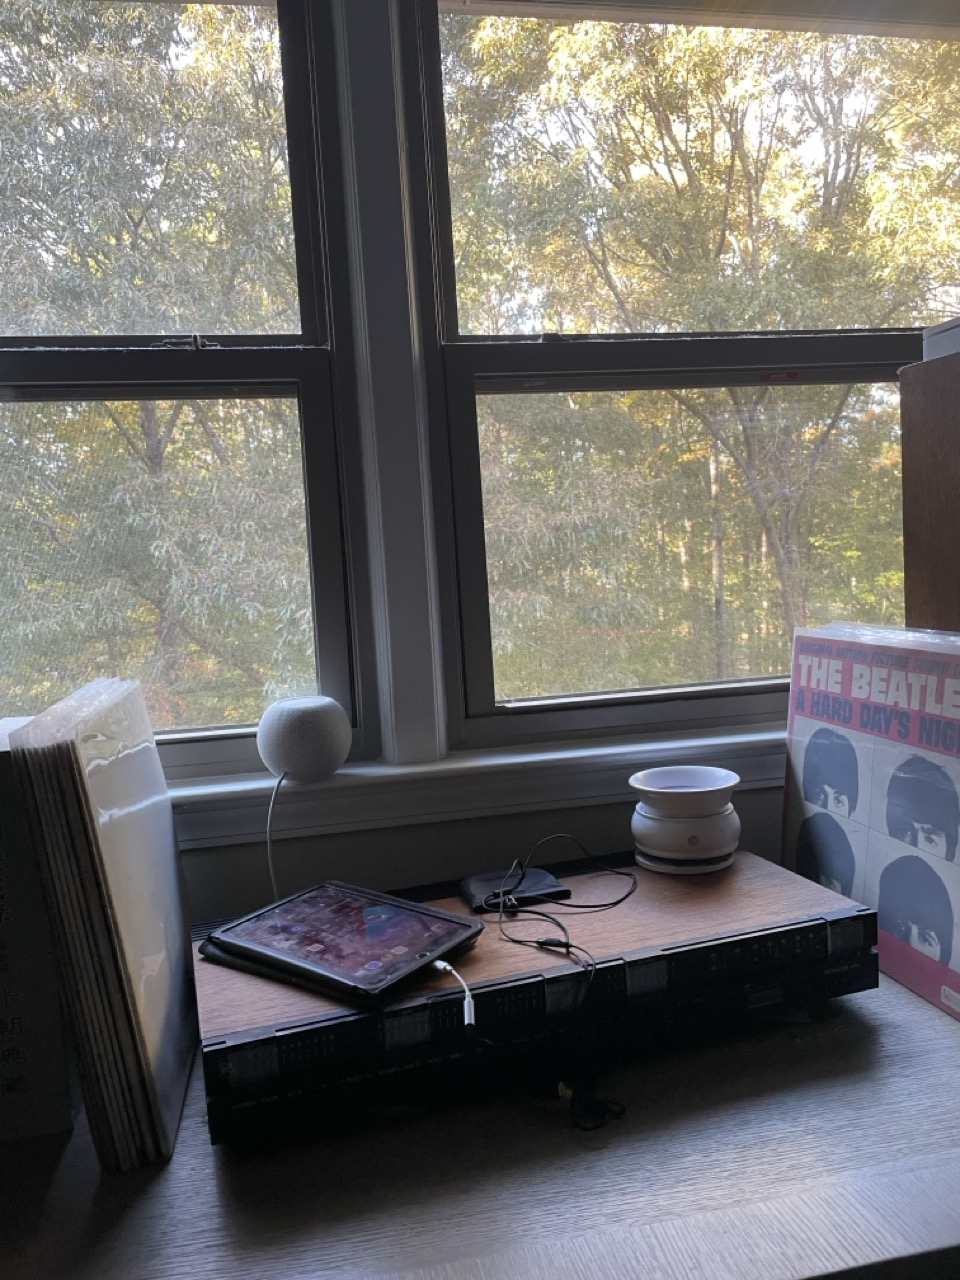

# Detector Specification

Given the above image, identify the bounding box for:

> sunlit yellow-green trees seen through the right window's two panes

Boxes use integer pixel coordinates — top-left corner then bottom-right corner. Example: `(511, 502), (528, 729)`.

(442, 15), (931, 696)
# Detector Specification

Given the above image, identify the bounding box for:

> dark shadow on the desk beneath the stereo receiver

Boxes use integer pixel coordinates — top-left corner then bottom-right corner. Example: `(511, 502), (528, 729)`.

(216, 1002), (878, 1243)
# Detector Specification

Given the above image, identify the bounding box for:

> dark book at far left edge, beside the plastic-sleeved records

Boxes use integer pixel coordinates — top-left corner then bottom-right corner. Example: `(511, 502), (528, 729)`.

(0, 717), (73, 1139)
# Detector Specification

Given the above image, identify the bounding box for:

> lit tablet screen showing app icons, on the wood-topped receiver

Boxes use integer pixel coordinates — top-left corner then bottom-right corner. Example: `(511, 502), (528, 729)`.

(218, 884), (475, 987)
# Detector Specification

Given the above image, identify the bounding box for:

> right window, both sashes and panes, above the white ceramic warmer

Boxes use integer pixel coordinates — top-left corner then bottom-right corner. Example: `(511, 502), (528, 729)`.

(407, 0), (960, 745)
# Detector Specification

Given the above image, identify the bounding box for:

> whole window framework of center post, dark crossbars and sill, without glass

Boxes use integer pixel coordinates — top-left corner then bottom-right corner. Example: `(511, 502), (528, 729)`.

(0, 0), (956, 849)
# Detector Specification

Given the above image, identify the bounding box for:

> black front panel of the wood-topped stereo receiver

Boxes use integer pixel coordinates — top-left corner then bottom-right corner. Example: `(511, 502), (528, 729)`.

(195, 854), (878, 1142)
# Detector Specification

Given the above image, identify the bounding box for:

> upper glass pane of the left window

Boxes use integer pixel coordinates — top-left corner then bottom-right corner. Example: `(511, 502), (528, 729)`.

(0, 0), (300, 335)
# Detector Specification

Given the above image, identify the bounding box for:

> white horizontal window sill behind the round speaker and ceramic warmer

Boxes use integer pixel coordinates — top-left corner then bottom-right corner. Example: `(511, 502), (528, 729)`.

(170, 724), (785, 850)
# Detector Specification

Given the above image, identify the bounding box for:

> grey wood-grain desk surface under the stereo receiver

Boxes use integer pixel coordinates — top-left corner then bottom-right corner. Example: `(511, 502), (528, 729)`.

(0, 979), (960, 1280)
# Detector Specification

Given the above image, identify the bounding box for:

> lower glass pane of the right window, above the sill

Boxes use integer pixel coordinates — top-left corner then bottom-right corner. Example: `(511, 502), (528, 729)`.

(477, 384), (904, 700)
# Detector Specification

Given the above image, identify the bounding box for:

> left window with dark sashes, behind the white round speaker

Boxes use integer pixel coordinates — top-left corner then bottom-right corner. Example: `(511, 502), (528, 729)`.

(0, 0), (358, 747)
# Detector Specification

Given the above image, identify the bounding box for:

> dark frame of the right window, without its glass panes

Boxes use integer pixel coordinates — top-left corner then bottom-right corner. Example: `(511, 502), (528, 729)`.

(403, 0), (942, 750)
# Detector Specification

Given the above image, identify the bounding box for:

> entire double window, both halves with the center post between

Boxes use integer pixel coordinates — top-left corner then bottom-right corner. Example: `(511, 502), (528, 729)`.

(0, 0), (960, 824)
